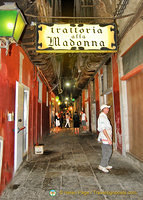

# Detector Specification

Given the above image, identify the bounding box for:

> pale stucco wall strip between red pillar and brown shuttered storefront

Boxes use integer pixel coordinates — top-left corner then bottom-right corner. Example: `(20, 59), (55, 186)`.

(117, 18), (143, 155)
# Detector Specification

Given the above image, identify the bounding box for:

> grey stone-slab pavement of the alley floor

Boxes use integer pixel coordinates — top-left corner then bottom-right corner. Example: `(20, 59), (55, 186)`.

(0, 129), (143, 200)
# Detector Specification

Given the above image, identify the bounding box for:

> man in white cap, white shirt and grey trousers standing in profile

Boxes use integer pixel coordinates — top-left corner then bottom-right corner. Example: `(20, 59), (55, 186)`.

(98, 104), (112, 173)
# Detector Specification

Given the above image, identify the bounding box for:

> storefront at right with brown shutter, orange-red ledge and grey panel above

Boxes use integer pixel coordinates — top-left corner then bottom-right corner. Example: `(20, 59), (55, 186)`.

(121, 37), (143, 161)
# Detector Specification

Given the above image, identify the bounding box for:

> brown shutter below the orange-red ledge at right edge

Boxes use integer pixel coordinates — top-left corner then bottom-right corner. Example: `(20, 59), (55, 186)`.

(127, 72), (143, 161)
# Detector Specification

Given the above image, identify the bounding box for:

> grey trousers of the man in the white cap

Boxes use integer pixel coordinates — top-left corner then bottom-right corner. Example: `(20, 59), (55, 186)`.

(100, 143), (112, 167)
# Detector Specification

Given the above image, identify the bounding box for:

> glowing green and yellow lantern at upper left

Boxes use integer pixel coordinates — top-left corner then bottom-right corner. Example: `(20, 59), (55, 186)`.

(0, 2), (26, 55)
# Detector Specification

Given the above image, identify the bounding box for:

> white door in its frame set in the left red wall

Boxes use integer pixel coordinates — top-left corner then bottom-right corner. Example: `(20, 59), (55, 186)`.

(14, 82), (29, 172)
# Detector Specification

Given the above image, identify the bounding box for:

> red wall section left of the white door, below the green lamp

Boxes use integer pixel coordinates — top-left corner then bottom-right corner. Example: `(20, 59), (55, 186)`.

(0, 46), (19, 192)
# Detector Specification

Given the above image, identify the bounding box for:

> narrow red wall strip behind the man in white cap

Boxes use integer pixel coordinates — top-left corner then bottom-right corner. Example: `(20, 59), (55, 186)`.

(112, 54), (122, 152)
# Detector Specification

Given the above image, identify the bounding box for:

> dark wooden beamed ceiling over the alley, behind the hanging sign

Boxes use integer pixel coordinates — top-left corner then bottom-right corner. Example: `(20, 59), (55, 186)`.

(0, 0), (115, 97)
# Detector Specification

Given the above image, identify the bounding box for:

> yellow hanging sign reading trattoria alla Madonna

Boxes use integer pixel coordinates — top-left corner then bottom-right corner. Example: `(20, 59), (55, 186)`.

(36, 24), (117, 53)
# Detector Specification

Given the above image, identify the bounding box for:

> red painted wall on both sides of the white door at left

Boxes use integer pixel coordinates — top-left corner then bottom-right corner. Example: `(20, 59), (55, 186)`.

(0, 45), (50, 193)
